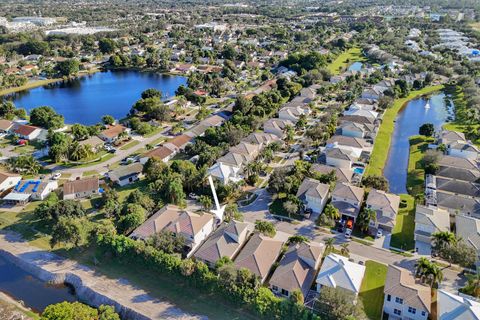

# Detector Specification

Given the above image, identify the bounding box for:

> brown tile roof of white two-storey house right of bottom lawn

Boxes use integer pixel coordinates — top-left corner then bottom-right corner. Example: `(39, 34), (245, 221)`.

(383, 265), (432, 312)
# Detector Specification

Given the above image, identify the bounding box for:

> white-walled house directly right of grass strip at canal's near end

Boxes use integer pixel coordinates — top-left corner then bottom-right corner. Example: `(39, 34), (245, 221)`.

(414, 204), (450, 255)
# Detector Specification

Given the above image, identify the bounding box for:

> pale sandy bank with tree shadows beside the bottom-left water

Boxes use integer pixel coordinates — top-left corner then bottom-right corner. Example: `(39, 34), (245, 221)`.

(0, 231), (205, 320)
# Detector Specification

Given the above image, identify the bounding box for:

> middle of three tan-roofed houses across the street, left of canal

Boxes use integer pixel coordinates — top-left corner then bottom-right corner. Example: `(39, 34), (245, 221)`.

(331, 183), (365, 222)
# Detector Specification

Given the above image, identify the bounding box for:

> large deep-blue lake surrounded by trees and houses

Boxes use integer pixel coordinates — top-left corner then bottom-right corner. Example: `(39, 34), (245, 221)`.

(10, 71), (187, 125)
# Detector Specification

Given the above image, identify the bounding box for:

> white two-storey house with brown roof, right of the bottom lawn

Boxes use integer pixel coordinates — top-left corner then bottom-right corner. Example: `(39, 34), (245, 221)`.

(383, 265), (432, 320)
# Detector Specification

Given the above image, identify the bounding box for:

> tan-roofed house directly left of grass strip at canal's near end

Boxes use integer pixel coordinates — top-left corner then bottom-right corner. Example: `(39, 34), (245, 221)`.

(365, 189), (400, 232)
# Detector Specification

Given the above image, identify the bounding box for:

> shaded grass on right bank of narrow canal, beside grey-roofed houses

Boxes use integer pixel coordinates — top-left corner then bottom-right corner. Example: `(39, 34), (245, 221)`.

(407, 136), (434, 196)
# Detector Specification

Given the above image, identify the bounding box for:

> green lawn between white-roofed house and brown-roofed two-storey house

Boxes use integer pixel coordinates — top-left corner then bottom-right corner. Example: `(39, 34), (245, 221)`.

(359, 260), (387, 320)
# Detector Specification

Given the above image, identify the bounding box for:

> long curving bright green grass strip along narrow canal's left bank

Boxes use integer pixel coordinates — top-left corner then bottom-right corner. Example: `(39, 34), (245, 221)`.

(365, 85), (443, 176)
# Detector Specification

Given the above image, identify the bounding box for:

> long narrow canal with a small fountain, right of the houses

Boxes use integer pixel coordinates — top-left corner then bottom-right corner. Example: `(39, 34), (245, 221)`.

(383, 93), (453, 194)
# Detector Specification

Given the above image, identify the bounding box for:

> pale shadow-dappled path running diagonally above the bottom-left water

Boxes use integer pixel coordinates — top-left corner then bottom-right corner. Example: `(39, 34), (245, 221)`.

(0, 231), (207, 320)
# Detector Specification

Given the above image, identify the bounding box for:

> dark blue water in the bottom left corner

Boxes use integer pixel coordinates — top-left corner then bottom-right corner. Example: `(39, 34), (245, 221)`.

(0, 256), (77, 313)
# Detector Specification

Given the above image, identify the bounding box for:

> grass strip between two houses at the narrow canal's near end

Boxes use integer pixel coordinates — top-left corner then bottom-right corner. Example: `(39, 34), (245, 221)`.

(390, 194), (415, 250)
